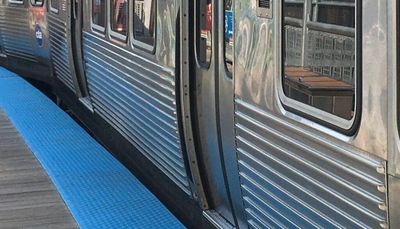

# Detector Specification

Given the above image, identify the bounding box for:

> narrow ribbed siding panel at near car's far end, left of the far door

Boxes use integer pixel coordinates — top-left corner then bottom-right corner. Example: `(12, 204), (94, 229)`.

(48, 13), (75, 92)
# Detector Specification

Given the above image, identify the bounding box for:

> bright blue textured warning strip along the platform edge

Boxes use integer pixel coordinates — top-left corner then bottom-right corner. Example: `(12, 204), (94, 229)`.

(0, 68), (184, 228)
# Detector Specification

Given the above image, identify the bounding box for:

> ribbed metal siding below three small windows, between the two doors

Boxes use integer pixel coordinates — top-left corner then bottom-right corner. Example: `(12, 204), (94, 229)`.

(84, 33), (190, 194)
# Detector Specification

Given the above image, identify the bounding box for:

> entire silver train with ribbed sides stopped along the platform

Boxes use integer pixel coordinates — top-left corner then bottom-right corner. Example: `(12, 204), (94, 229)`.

(0, 0), (400, 228)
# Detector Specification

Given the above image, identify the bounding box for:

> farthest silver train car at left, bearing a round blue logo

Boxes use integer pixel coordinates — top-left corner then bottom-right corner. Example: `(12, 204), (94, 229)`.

(0, 0), (53, 83)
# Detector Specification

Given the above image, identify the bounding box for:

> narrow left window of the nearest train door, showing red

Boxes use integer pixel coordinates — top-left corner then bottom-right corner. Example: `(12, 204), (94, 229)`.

(197, 0), (212, 67)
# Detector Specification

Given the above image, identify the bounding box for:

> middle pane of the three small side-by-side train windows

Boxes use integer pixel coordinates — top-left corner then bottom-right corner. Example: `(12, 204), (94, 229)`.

(111, 0), (128, 36)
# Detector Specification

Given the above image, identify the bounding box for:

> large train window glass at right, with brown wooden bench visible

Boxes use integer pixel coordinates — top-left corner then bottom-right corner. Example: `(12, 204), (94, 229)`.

(282, 0), (356, 120)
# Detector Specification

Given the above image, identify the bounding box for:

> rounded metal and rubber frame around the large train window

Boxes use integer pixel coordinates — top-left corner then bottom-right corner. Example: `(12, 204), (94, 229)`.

(277, 0), (363, 136)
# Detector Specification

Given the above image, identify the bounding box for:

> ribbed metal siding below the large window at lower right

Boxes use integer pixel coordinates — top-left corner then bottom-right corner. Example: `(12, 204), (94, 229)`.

(235, 99), (387, 228)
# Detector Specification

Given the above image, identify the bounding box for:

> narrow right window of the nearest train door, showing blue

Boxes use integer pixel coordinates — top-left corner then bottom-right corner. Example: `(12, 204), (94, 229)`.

(224, 0), (233, 73)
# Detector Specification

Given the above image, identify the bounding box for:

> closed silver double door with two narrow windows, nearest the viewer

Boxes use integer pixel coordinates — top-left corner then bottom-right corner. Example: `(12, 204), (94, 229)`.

(189, 0), (242, 226)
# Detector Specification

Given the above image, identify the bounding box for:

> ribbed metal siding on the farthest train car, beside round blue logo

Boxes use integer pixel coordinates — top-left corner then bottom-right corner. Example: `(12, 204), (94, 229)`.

(0, 6), (36, 61)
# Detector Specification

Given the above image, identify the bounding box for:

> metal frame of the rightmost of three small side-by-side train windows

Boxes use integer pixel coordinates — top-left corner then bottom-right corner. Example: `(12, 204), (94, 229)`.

(129, 0), (158, 54)
